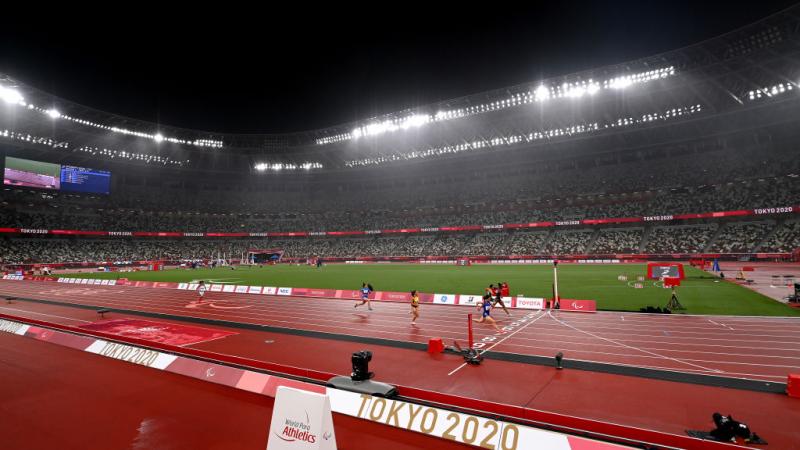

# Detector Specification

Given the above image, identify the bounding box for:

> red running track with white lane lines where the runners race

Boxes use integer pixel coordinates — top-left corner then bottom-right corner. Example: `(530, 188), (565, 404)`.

(0, 281), (800, 383)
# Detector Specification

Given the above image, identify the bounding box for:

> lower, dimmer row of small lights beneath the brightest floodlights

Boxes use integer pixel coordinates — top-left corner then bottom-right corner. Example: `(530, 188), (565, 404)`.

(345, 104), (703, 168)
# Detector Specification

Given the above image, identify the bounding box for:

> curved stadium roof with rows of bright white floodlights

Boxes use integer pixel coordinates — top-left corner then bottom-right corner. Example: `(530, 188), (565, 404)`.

(0, 6), (800, 171)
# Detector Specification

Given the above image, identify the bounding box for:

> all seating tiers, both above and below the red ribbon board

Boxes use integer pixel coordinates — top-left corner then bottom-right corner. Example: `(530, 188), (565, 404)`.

(0, 144), (800, 262)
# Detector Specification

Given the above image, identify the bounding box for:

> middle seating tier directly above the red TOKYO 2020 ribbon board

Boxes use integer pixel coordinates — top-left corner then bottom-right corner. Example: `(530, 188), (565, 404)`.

(0, 177), (800, 232)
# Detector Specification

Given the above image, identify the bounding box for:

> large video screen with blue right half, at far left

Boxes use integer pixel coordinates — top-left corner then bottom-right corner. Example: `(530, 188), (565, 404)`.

(3, 156), (111, 194)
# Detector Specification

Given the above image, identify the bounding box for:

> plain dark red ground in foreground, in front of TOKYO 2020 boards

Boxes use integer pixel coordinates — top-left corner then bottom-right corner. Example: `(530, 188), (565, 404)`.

(0, 333), (476, 450)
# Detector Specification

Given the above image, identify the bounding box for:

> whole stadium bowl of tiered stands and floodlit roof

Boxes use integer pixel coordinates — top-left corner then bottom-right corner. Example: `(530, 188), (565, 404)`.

(0, 7), (800, 264)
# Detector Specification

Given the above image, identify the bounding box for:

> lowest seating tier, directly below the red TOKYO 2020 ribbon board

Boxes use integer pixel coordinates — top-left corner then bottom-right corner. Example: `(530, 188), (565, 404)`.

(0, 221), (800, 264)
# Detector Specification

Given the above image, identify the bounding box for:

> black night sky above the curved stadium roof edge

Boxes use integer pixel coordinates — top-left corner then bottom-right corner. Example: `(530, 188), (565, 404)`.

(0, 0), (793, 132)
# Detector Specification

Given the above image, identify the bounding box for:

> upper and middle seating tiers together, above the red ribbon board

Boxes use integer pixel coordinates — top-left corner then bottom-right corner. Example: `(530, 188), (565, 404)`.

(0, 146), (800, 236)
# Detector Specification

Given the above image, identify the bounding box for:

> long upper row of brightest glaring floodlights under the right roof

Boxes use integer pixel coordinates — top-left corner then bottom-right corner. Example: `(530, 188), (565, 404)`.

(315, 66), (675, 145)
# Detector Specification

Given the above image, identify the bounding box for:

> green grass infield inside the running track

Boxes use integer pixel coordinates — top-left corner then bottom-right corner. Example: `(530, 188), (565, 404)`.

(62, 264), (800, 316)
